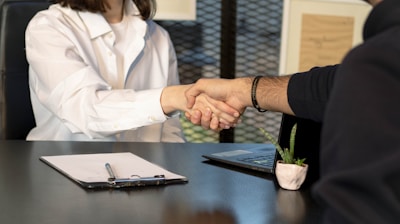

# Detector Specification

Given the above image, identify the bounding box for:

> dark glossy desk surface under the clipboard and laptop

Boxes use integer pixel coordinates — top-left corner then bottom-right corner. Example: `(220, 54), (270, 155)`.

(0, 141), (321, 224)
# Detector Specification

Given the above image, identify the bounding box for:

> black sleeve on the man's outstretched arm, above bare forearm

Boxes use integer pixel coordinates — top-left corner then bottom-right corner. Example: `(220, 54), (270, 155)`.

(287, 65), (338, 122)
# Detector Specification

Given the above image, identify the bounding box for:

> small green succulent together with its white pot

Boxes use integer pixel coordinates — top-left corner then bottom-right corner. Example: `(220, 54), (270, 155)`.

(260, 124), (308, 190)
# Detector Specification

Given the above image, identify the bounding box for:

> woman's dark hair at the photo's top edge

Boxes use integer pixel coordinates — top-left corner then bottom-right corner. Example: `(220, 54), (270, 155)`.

(51, 0), (157, 20)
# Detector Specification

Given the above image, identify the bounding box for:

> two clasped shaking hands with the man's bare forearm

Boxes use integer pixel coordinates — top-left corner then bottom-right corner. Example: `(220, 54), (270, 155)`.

(161, 76), (293, 131)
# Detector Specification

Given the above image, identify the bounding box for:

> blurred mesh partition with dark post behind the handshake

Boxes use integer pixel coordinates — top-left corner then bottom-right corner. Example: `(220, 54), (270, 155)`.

(157, 0), (283, 143)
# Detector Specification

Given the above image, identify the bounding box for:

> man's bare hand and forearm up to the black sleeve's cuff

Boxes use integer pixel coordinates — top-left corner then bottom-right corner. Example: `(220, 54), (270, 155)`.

(186, 76), (293, 130)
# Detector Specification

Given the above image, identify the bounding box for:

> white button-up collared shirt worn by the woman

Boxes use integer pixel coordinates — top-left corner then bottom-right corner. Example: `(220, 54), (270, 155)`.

(26, 1), (184, 142)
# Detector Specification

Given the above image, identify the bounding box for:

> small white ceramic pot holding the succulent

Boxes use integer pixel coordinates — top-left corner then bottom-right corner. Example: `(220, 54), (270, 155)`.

(275, 160), (308, 190)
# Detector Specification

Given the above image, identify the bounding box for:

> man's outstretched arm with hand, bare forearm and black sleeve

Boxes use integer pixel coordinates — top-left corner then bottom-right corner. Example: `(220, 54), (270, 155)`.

(186, 65), (338, 130)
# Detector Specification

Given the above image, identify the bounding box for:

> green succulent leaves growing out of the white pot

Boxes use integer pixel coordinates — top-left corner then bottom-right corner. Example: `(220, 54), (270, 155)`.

(260, 123), (306, 166)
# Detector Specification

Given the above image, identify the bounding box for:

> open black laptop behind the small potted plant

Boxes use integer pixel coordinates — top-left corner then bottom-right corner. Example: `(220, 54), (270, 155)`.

(203, 114), (321, 182)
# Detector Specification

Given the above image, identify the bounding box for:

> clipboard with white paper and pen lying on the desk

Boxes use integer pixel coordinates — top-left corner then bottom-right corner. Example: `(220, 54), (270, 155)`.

(39, 152), (188, 189)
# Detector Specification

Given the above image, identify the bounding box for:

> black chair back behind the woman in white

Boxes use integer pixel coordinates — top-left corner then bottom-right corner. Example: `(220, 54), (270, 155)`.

(0, 0), (49, 139)
